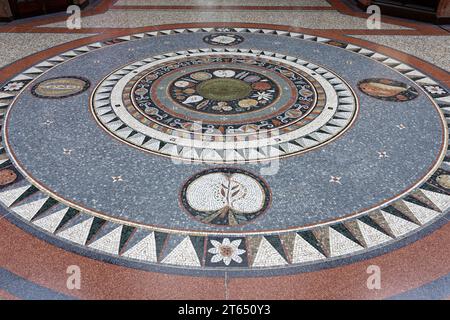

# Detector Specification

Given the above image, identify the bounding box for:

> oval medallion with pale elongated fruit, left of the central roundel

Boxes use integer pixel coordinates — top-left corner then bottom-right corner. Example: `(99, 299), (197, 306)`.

(31, 77), (91, 99)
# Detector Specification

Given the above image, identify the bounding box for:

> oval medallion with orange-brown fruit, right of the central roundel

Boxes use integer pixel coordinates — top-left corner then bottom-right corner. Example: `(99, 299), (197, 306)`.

(358, 78), (419, 102)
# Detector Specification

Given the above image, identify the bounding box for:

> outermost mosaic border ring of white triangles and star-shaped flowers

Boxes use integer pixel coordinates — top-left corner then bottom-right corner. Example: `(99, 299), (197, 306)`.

(0, 28), (450, 272)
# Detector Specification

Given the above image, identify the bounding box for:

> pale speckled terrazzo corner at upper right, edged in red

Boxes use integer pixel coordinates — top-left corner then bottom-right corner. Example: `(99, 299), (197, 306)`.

(353, 35), (450, 71)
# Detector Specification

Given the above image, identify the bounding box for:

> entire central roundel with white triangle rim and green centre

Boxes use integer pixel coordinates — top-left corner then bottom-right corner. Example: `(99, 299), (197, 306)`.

(92, 49), (358, 163)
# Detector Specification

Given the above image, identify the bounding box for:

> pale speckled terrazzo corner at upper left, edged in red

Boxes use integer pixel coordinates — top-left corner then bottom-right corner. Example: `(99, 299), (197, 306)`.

(0, 33), (94, 68)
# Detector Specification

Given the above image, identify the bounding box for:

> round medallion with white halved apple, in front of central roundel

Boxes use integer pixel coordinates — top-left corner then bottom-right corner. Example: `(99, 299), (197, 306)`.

(181, 168), (270, 226)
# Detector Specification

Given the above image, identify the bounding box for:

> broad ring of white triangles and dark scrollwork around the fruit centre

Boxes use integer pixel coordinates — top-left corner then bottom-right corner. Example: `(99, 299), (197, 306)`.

(92, 49), (359, 163)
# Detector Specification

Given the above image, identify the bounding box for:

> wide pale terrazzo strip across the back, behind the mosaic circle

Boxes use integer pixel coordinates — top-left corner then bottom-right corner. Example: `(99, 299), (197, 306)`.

(43, 10), (408, 29)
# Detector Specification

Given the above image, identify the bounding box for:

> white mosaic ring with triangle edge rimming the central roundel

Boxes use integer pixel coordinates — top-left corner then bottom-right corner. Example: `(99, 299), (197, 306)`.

(92, 49), (358, 163)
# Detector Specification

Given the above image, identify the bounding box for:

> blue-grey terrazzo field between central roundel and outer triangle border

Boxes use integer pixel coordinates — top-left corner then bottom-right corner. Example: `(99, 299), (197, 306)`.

(5, 34), (442, 231)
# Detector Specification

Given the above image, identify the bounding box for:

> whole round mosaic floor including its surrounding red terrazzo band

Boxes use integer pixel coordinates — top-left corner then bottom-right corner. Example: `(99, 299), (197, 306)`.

(0, 1), (450, 299)
